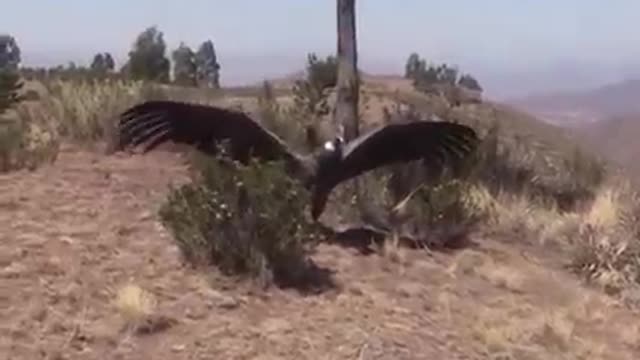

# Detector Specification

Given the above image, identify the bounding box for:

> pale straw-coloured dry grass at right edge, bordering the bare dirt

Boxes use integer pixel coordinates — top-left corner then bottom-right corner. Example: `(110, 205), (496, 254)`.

(468, 176), (640, 302)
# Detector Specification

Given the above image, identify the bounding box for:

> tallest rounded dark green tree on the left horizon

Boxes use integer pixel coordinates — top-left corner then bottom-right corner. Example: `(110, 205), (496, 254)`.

(127, 26), (170, 83)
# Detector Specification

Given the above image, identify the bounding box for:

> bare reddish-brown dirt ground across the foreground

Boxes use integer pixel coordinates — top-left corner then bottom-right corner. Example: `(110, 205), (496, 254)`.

(0, 148), (640, 360)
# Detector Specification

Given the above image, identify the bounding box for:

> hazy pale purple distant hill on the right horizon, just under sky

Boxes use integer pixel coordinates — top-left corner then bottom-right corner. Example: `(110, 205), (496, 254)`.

(506, 79), (640, 125)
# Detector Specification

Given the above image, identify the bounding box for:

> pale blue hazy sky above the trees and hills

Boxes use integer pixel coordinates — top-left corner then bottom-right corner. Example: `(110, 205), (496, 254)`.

(0, 0), (640, 97)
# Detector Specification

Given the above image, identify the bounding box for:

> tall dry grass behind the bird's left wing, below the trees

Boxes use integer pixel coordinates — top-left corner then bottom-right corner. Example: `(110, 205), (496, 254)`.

(0, 80), (270, 171)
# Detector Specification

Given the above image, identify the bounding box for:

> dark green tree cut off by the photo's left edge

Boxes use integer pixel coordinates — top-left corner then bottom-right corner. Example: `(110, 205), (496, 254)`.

(0, 35), (23, 115)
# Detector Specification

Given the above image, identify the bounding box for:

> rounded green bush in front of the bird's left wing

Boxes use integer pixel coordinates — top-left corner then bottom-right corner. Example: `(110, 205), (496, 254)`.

(160, 150), (318, 285)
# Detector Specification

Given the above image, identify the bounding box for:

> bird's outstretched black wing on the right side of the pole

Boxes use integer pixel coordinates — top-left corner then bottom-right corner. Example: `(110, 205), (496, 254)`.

(333, 121), (478, 185)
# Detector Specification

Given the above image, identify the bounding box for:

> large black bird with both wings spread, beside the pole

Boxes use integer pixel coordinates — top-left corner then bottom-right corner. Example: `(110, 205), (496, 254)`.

(119, 101), (478, 221)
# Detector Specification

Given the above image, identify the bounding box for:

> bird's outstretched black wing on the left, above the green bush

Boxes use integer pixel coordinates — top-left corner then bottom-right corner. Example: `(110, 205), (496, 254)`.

(119, 101), (296, 163)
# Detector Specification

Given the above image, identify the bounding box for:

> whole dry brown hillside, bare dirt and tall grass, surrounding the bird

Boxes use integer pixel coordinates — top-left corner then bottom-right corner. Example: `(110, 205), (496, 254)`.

(0, 76), (640, 359)
